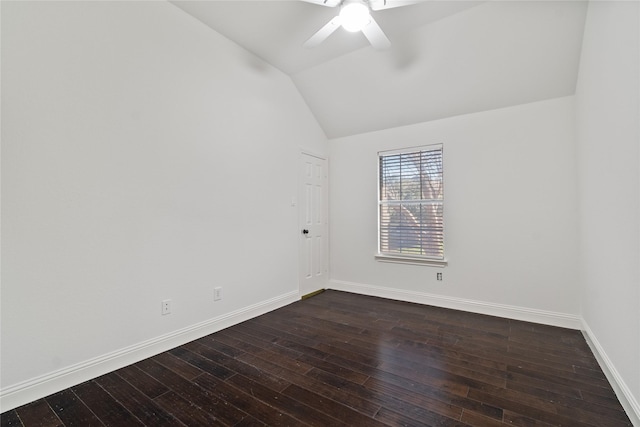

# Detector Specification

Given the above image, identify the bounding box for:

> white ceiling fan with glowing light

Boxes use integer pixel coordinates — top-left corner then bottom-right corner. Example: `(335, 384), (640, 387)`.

(302, 0), (420, 50)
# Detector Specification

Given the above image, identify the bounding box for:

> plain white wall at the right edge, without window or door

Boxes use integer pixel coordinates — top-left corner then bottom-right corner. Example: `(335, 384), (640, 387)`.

(576, 2), (640, 425)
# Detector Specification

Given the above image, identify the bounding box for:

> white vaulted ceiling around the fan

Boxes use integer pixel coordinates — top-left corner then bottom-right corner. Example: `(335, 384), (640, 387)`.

(172, 0), (587, 138)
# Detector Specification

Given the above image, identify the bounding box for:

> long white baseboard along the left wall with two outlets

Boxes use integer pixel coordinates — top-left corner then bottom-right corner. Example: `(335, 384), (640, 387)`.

(0, 290), (300, 412)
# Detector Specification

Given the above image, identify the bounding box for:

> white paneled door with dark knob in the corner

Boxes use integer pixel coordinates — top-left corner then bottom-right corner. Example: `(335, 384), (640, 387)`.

(298, 153), (329, 296)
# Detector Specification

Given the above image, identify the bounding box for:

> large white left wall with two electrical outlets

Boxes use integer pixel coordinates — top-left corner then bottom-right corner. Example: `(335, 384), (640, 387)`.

(1, 2), (327, 410)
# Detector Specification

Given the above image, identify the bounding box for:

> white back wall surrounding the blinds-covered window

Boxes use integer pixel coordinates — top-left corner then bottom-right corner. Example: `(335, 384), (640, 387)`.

(329, 97), (579, 328)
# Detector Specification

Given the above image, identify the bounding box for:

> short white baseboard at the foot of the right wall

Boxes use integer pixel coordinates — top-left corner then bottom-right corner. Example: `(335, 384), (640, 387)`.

(582, 319), (640, 427)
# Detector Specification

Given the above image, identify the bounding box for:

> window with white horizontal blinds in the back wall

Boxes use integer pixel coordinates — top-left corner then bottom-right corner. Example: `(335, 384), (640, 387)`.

(378, 145), (445, 264)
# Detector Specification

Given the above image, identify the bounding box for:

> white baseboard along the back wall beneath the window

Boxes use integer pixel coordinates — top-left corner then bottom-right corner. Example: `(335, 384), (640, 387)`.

(329, 280), (582, 329)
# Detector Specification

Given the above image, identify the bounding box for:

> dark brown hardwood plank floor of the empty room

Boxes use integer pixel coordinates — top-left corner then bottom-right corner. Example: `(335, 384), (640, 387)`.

(1, 291), (631, 427)
